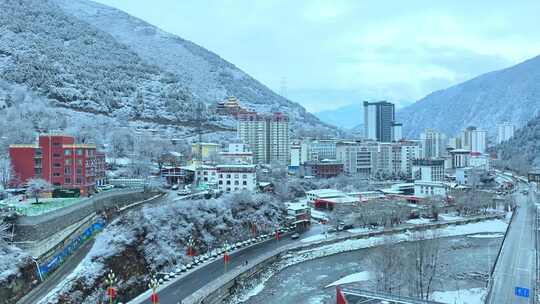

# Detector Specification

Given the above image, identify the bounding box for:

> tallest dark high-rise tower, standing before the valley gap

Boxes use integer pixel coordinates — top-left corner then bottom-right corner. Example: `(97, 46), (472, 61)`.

(364, 101), (401, 142)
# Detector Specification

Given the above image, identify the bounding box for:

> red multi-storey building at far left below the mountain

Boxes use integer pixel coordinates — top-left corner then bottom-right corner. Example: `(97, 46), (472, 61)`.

(9, 134), (105, 196)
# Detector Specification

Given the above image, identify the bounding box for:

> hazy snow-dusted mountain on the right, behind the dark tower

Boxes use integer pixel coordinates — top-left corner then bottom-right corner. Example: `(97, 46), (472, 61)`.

(397, 56), (540, 137)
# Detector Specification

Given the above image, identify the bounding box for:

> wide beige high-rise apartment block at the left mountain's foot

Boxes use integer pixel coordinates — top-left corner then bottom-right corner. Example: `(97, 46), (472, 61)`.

(237, 112), (290, 164)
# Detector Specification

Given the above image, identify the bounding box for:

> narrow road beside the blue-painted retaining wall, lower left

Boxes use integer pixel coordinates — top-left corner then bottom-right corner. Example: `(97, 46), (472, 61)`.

(17, 239), (94, 304)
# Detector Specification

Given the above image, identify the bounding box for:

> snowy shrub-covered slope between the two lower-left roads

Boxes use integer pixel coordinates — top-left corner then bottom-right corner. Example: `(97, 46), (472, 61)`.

(40, 193), (286, 303)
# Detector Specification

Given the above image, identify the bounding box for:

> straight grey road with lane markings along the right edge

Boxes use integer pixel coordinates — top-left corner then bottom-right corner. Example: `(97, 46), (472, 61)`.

(488, 184), (536, 304)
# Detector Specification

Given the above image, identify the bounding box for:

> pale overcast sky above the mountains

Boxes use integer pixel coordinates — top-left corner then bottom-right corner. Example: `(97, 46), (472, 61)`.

(98, 0), (540, 112)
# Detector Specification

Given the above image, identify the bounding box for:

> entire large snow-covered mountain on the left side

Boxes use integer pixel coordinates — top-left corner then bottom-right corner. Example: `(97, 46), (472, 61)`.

(0, 0), (334, 134)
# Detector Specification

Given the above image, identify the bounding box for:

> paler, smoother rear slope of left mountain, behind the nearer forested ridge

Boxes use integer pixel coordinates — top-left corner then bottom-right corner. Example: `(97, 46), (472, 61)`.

(53, 0), (330, 132)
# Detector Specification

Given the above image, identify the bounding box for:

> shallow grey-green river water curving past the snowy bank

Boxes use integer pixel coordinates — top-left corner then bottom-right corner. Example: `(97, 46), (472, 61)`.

(234, 235), (502, 304)
